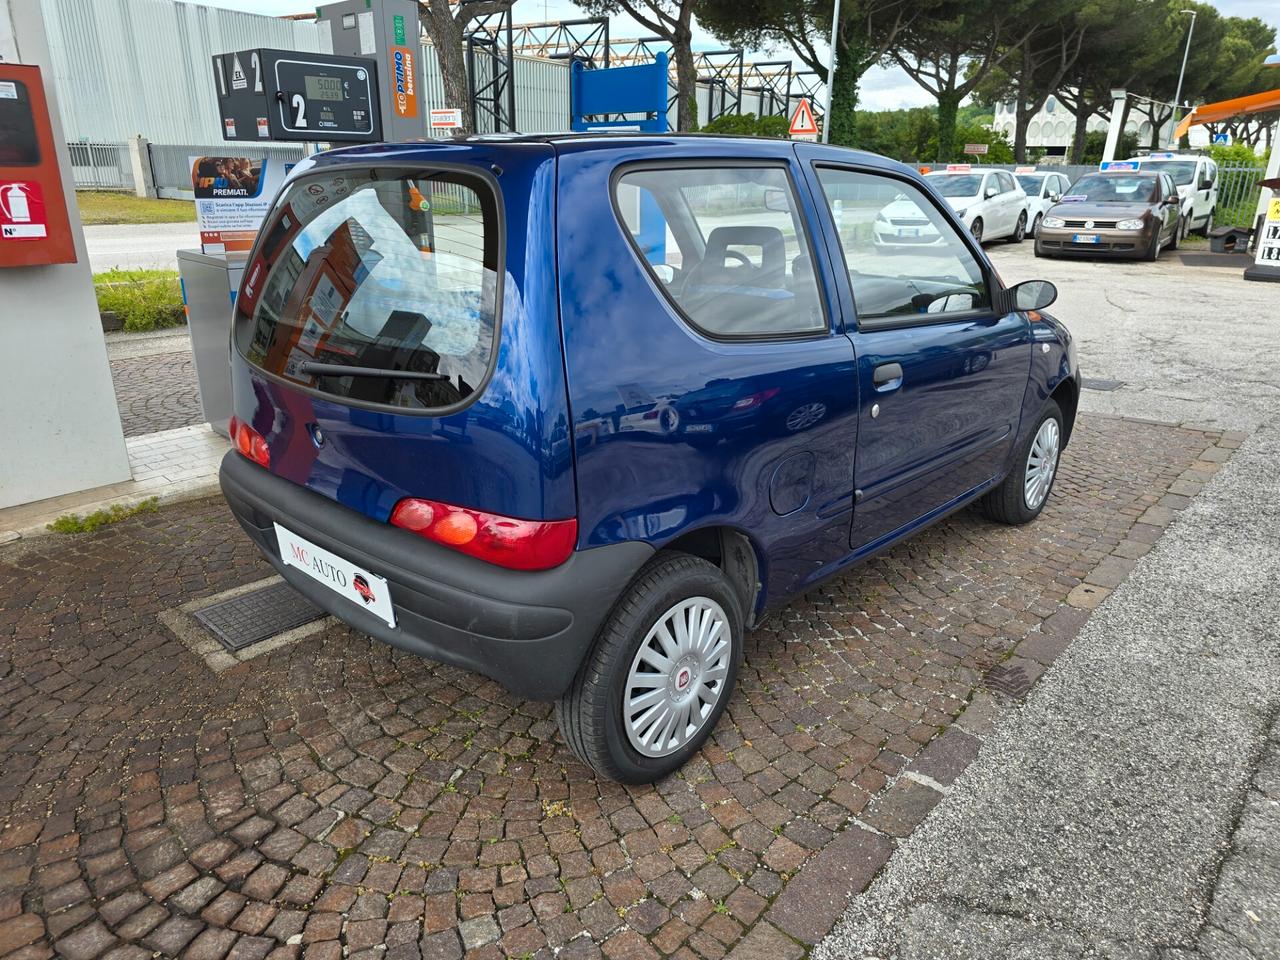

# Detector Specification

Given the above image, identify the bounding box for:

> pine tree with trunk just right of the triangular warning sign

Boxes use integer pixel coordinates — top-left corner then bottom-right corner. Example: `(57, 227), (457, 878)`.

(698, 0), (940, 146)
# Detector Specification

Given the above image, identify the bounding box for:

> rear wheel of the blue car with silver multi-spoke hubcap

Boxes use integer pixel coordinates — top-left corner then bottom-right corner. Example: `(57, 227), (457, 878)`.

(556, 553), (744, 783)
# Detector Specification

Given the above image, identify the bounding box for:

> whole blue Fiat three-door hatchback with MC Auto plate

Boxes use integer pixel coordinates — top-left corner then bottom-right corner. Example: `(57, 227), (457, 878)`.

(221, 136), (1079, 782)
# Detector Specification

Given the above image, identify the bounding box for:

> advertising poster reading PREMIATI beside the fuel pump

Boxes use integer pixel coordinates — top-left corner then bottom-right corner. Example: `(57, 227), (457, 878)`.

(191, 156), (293, 256)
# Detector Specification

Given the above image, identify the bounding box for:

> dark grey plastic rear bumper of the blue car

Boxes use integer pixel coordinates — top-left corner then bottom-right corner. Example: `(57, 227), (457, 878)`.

(219, 451), (654, 700)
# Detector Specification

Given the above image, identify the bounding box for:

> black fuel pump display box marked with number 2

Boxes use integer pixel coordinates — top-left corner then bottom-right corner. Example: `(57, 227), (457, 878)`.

(214, 49), (383, 143)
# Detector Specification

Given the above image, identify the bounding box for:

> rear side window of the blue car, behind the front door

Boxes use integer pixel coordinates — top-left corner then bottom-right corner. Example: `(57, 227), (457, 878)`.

(613, 164), (827, 338)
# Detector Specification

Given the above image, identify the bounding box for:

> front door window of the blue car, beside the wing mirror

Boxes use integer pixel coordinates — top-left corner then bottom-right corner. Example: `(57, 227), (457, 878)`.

(817, 166), (991, 329)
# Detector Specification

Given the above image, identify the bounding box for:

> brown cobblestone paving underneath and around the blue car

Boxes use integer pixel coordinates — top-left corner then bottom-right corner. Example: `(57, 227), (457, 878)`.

(0, 417), (1228, 960)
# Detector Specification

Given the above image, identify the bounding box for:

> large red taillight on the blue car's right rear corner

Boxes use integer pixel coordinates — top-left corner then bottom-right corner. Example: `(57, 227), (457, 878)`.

(390, 498), (577, 570)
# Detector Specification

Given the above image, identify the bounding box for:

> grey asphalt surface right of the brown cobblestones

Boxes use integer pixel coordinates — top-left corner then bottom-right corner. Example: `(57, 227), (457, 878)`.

(814, 243), (1280, 960)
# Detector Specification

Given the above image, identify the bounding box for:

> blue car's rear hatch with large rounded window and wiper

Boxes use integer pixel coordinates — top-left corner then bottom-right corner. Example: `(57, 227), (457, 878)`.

(232, 141), (576, 521)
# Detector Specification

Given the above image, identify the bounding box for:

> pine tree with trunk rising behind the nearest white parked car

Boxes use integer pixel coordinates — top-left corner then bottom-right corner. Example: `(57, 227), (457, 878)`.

(888, 0), (1034, 161)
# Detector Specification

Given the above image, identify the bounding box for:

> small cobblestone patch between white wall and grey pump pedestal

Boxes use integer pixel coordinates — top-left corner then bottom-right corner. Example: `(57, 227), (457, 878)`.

(111, 349), (205, 436)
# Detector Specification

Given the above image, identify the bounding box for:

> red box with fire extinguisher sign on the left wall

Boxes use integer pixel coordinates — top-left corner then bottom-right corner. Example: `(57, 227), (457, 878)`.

(0, 63), (76, 266)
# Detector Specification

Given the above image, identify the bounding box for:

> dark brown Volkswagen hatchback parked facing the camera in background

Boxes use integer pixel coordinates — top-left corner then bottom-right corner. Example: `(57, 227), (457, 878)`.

(1036, 172), (1187, 260)
